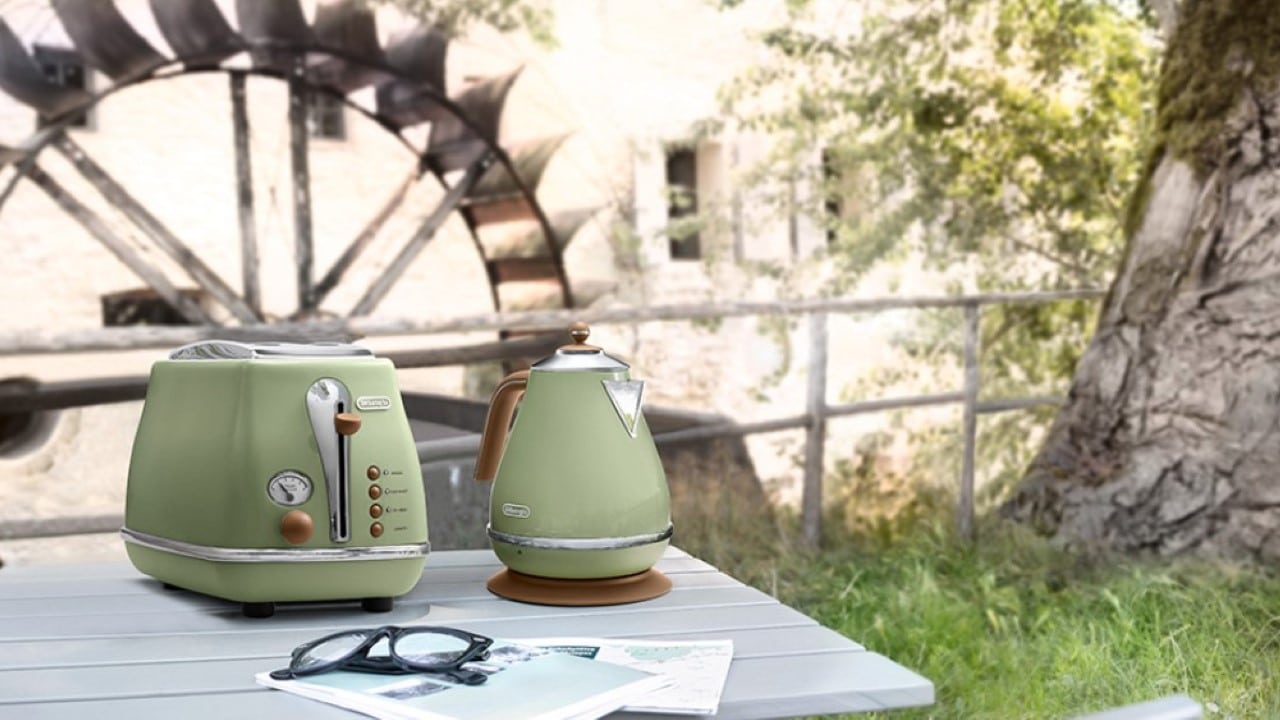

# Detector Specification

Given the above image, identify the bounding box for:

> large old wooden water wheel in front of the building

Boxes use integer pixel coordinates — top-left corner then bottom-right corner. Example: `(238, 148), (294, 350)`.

(0, 0), (604, 325)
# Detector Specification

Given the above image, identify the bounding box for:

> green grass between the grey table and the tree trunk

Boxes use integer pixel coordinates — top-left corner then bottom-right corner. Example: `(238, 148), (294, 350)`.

(673, 450), (1280, 719)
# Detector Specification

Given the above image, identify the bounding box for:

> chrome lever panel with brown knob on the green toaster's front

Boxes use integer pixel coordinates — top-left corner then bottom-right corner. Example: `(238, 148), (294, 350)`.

(306, 378), (360, 542)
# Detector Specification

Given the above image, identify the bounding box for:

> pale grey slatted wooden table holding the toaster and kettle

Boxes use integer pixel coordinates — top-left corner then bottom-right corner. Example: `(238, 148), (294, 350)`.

(0, 548), (933, 720)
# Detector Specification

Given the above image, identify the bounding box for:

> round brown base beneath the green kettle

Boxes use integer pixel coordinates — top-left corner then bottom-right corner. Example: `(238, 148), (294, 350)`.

(485, 568), (671, 607)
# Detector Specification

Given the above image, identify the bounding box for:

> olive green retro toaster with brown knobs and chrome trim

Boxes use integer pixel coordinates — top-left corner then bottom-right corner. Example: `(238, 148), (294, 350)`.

(120, 341), (430, 616)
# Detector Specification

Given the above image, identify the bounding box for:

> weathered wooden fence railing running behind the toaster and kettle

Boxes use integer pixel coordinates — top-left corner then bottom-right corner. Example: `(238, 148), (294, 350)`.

(0, 290), (1103, 543)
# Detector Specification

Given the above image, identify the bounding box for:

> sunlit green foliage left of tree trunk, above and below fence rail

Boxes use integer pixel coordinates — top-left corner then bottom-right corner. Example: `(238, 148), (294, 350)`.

(724, 0), (1160, 499)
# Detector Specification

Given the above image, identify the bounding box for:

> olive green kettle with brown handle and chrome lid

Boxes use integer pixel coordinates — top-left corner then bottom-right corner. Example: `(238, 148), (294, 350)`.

(476, 323), (672, 605)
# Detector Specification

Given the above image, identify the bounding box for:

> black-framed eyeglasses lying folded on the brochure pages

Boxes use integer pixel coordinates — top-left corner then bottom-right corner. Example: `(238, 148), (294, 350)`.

(271, 625), (493, 685)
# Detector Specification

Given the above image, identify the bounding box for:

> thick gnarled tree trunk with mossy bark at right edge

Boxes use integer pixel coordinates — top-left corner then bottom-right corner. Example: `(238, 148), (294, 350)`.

(1005, 0), (1280, 562)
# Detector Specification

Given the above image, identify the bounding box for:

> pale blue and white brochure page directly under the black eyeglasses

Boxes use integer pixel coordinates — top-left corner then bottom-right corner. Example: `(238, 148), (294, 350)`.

(256, 642), (669, 720)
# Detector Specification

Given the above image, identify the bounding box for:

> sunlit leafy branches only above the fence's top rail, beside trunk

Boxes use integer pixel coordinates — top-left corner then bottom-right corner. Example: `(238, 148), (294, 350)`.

(726, 0), (1156, 290)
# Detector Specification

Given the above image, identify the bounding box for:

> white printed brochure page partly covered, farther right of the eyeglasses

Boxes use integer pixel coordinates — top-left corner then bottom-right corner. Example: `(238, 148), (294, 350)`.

(518, 638), (733, 715)
